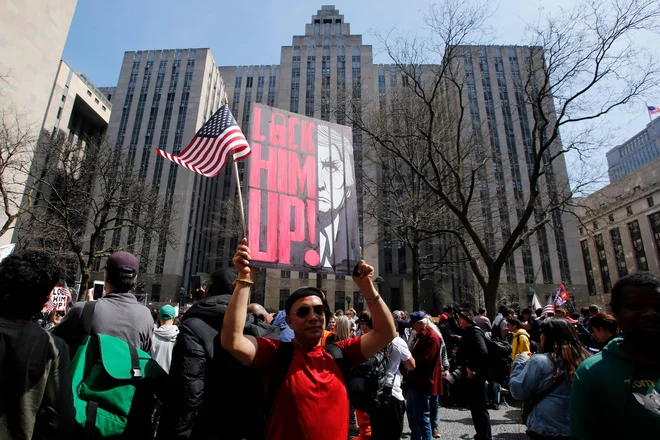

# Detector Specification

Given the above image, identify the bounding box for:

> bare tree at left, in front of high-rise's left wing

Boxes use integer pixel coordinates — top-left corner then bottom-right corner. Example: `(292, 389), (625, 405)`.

(19, 135), (178, 298)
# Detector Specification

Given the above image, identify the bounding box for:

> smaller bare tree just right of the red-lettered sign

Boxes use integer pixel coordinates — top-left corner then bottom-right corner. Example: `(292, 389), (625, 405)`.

(360, 90), (470, 310)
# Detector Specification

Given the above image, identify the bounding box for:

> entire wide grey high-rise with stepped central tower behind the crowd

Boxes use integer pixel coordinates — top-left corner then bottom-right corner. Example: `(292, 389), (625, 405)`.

(99, 6), (586, 311)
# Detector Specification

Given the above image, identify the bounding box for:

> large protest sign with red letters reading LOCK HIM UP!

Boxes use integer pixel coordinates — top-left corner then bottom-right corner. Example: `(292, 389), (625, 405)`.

(247, 104), (360, 275)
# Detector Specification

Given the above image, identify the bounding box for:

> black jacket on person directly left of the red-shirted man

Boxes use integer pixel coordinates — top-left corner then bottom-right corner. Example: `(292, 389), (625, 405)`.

(157, 295), (279, 440)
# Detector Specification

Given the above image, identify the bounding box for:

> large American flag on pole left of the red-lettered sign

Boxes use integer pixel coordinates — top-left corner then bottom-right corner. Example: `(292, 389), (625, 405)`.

(156, 104), (251, 177)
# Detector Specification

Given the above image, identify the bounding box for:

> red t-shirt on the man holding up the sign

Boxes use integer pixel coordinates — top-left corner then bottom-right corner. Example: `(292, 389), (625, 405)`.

(253, 338), (366, 440)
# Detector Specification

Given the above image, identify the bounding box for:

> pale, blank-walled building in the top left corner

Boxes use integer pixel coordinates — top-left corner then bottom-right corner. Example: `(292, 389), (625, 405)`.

(0, 0), (77, 245)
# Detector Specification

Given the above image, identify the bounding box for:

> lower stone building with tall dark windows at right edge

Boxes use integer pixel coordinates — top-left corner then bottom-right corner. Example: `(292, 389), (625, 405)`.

(576, 159), (660, 305)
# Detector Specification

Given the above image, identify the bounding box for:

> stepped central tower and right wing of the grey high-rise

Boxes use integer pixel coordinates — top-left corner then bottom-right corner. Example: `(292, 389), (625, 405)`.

(220, 6), (586, 310)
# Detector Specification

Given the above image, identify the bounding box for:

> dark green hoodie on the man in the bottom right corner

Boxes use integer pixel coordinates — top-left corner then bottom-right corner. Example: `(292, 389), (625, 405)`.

(571, 338), (660, 440)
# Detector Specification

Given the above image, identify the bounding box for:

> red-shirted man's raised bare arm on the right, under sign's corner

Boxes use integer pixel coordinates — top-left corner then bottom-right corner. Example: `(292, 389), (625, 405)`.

(353, 260), (396, 359)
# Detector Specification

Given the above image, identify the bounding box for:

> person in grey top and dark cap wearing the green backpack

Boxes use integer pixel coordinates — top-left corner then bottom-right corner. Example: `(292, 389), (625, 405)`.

(53, 251), (154, 356)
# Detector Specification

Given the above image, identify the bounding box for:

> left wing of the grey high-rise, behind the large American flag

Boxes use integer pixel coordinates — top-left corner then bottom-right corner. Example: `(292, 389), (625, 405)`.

(102, 49), (226, 301)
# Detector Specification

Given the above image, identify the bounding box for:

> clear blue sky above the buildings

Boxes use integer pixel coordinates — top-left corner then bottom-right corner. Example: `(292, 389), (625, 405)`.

(62, 0), (660, 187)
